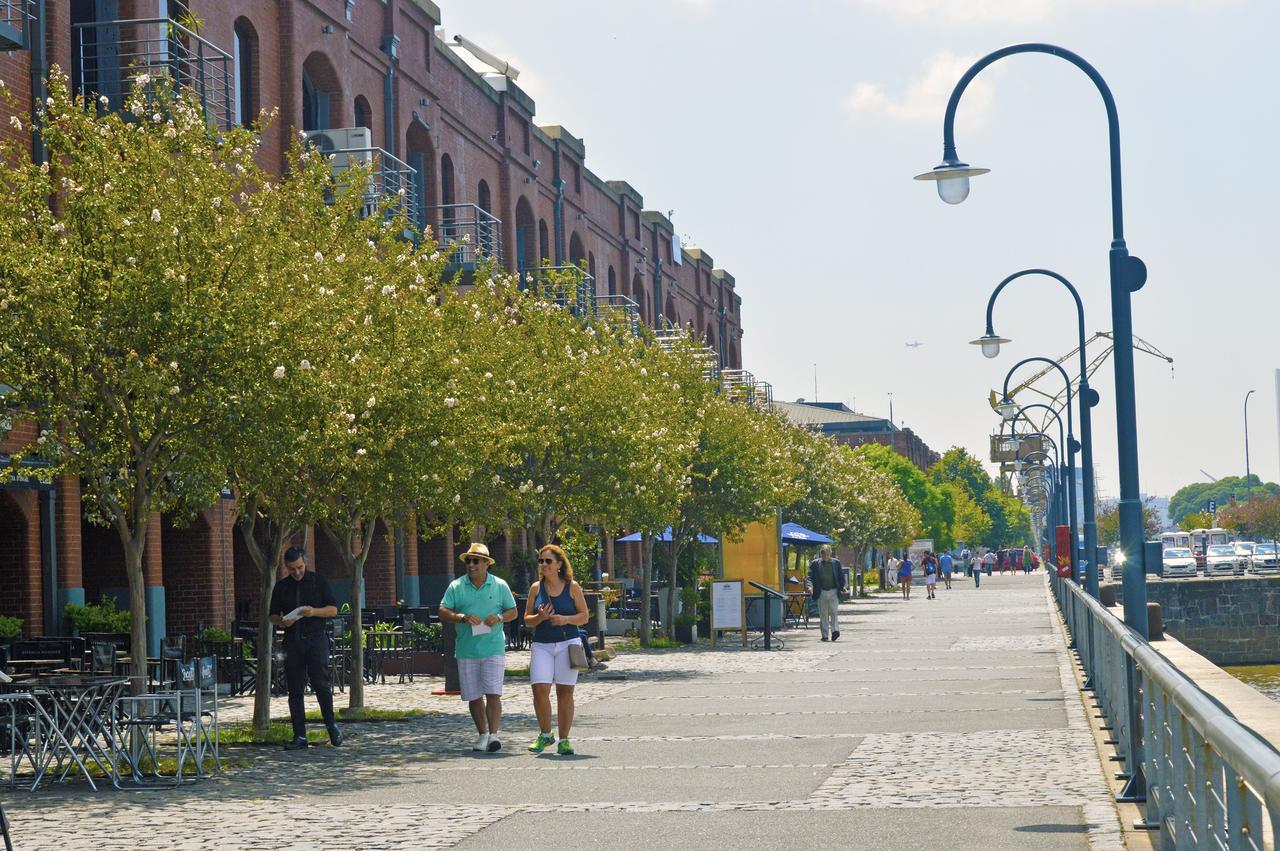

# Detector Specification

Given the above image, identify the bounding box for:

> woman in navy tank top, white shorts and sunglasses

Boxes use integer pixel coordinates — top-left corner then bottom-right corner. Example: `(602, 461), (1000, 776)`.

(525, 544), (588, 755)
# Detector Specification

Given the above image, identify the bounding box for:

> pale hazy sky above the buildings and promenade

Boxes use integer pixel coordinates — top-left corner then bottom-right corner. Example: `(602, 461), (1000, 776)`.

(440, 0), (1280, 497)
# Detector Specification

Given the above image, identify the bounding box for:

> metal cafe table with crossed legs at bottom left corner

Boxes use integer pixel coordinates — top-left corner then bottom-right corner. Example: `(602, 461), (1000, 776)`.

(3, 674), (129, 791)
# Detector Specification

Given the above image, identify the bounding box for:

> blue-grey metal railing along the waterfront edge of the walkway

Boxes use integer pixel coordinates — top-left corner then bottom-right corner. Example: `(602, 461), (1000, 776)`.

(1051, 575), (1280, 851)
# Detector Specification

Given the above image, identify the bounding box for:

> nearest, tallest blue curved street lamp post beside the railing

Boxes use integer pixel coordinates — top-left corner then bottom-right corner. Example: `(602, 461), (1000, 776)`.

(918, 44), (1148, 639)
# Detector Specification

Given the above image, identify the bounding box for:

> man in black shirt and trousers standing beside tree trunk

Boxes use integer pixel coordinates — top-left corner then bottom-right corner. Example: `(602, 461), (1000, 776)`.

(271, 546), (342, 750)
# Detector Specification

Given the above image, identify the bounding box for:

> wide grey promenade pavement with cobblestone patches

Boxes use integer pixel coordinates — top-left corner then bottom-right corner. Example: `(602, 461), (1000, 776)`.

(4, 575), (1123, 851)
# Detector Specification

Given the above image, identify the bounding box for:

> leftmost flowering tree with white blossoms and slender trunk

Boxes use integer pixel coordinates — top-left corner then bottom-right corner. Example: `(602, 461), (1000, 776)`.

(0, 69), (264, 688)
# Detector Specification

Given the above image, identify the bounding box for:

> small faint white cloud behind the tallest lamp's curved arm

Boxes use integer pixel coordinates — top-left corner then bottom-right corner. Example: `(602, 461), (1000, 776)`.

(845, 52), (996, 127)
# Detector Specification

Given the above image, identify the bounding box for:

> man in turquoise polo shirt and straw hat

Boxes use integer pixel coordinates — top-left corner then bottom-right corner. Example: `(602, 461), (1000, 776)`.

(440, 544), (516, 754)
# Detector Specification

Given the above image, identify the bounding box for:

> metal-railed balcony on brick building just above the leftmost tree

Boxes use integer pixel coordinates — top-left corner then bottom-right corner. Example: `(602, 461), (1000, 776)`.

(72, 18), (236, 129)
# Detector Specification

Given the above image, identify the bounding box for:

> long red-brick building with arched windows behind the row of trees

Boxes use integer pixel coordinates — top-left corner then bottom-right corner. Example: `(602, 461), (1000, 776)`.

(0, 0), (742, 646)
